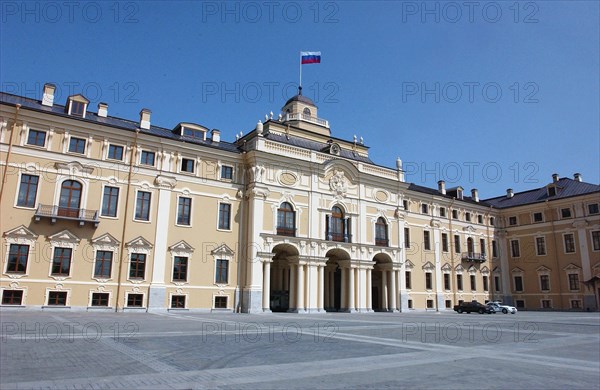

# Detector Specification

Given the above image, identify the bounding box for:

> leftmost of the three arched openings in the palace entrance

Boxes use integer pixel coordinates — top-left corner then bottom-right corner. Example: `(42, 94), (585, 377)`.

(269, 244), (299, 312)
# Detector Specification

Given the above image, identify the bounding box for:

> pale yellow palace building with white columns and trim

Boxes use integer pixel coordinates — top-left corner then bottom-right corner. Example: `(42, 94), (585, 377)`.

(0, 84), (600, 313)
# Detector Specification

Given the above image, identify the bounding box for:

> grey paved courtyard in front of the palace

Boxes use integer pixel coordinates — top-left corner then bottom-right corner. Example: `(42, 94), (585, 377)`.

(0, 310), (600, 389)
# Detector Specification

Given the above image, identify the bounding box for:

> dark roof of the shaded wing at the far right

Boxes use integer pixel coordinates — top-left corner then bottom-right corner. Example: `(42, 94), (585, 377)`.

(484, 177), (600, 209)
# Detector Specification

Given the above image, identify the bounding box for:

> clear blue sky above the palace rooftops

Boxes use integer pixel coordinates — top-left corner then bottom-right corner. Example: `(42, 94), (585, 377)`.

(0, 1), (600, 198)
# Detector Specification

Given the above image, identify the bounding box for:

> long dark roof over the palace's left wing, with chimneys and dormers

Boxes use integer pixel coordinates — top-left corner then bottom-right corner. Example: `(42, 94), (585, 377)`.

(0, 92), (240, 153)
